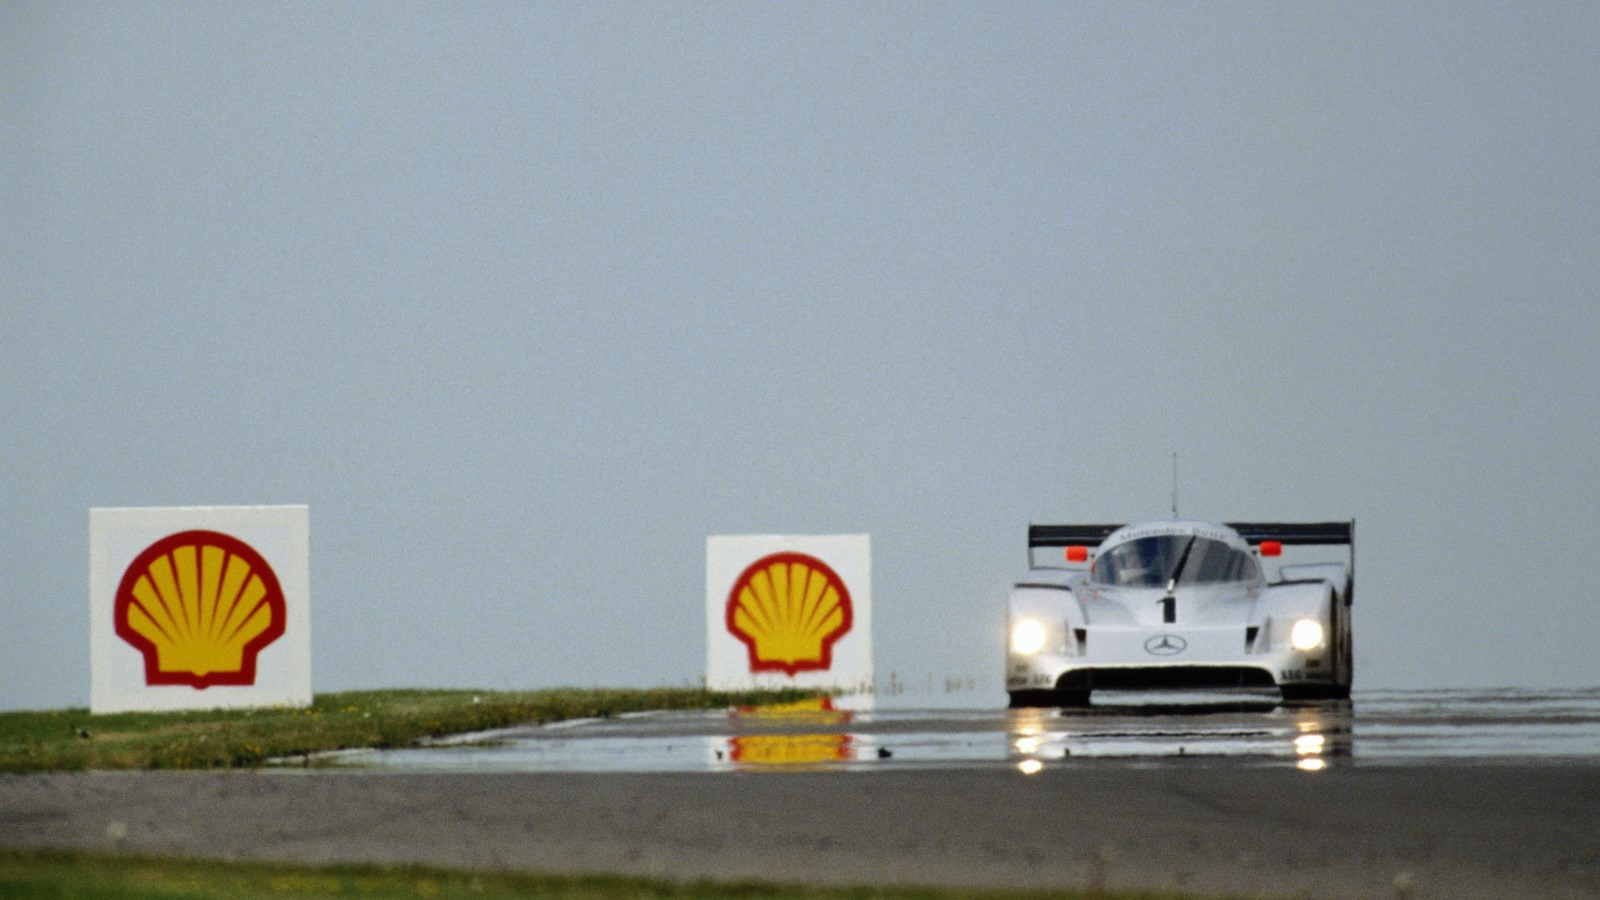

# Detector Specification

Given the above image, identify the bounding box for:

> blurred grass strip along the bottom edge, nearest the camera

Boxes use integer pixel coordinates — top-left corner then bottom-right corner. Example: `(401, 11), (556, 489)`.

(0, 852), (1203, 900)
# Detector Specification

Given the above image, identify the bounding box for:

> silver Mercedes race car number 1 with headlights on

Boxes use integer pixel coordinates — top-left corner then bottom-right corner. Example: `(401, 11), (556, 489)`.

(1006, 520), (1355, 706)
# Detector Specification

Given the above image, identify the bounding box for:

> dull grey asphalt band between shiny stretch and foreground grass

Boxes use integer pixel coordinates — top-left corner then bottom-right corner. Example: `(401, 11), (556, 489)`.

(0, 761), (1600, 898)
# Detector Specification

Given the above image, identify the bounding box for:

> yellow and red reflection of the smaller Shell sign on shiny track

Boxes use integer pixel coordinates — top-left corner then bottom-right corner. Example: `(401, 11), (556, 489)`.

(717, 697), (858, 769)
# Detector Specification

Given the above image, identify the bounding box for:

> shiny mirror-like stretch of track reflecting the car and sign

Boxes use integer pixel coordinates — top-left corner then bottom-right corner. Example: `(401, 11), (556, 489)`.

(312, 690), (1600, 773)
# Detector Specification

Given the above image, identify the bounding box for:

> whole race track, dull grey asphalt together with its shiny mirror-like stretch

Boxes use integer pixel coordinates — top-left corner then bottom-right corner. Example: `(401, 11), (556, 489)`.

(0, 682), (1600, 898)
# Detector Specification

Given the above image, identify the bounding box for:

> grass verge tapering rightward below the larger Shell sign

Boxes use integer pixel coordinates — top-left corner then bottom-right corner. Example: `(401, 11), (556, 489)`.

(0, 689), (808, 772)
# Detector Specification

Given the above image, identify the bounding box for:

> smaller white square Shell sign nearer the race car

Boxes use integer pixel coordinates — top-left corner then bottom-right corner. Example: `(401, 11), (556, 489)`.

(706, 535), (872, 690)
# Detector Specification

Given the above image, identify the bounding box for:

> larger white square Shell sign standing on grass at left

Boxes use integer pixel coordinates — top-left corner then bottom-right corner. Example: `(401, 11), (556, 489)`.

(90, 506), (310, 713)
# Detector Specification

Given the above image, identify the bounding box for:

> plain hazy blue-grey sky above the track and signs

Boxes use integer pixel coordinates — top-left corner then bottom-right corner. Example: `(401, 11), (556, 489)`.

(0, 2), (1600, 708)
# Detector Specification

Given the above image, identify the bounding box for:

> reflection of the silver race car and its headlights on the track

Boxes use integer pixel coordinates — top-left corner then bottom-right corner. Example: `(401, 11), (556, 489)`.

(1008, 685), (1354, 775)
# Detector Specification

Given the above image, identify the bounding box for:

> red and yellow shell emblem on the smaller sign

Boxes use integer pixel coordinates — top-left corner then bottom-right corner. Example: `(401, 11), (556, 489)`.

(728, 552), (851, 676)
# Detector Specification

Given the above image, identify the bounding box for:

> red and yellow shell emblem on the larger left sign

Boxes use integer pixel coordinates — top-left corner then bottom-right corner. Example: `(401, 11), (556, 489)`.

(114, 532), (286, 689)
